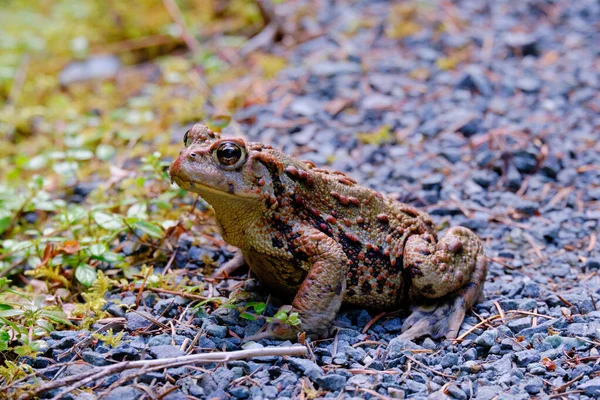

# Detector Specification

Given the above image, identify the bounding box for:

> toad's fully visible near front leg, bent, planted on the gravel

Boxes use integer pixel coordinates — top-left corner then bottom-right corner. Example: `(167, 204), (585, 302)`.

(246, 228), (348, 340)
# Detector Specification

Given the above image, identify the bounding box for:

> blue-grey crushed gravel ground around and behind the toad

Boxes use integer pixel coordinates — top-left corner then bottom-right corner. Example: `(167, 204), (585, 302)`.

(18, 0), (600, 400)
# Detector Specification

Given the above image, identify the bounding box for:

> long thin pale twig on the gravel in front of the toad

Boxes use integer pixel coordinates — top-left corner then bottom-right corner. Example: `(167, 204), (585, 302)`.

(19, 346), (307, 400)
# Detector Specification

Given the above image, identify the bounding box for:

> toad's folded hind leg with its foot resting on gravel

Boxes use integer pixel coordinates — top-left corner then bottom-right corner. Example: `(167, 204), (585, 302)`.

(400, 226), (487, 340)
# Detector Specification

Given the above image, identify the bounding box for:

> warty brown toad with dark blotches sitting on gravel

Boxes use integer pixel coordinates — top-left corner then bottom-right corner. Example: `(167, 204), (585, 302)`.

(170, 124), (486, 339)
